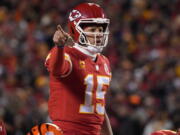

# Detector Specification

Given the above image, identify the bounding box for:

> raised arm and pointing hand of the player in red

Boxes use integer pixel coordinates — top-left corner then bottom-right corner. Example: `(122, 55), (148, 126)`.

(46, 25), (73, 76)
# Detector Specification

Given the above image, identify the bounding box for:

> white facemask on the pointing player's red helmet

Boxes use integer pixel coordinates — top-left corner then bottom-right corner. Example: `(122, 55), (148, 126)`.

(75, 18), (109, 48)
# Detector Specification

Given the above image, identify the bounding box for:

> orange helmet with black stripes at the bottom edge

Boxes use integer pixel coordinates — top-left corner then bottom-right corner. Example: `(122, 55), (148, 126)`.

(26, 123), (63, 135)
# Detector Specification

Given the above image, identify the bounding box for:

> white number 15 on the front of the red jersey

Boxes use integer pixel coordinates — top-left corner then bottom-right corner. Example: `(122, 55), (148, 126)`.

(79, 74), (110, 115)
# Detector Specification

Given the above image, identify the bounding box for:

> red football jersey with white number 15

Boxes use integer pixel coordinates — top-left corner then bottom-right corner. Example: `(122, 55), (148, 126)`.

(46, 47), (111, 135)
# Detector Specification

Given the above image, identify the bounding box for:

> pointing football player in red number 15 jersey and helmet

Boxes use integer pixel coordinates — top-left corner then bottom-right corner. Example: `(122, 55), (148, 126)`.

(45, 3), (113, 135)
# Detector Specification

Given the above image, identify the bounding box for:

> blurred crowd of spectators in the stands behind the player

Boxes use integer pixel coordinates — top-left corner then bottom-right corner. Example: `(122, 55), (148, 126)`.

(0, 0), (180, 135)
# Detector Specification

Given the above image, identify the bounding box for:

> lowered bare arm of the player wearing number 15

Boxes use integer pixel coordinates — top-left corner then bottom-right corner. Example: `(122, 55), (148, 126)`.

(101, 111), (113, 135)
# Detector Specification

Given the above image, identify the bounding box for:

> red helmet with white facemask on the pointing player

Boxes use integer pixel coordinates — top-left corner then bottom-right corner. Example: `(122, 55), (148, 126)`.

(68, 3), (110, 48)
